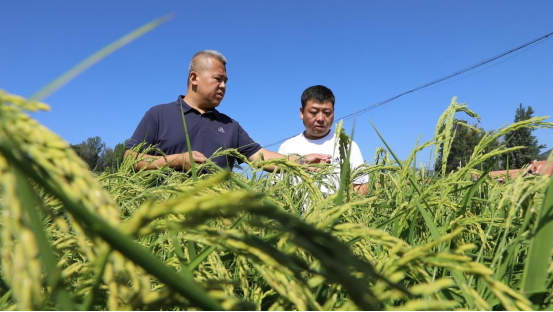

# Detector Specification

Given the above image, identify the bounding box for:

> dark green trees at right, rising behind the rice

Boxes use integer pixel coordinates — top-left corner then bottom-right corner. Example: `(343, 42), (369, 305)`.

(434, 104), (551, 172)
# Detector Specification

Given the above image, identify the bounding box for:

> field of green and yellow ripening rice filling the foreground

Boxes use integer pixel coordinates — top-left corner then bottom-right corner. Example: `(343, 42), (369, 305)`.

(0, 91), (553, 311)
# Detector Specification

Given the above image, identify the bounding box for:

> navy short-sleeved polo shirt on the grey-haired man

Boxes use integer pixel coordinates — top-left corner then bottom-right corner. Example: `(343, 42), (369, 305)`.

(126, 95), (261, 169)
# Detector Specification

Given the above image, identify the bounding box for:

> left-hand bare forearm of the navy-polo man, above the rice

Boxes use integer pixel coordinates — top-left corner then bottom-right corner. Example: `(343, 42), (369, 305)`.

(124, 150), (207, 171)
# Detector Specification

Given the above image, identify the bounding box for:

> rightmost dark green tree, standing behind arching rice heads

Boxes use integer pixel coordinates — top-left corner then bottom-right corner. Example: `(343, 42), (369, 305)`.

(506, 103), (546, 169)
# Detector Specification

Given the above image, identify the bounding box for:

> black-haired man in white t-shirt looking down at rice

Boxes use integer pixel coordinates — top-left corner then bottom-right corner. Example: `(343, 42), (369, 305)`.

(278, 85), (369, 195)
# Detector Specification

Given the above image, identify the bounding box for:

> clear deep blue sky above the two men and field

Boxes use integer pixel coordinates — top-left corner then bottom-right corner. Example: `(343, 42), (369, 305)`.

(0, 0), (553, 165)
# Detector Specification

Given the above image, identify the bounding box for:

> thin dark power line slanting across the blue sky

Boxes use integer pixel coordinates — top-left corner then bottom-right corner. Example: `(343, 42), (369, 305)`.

(265, 32), (553, 147)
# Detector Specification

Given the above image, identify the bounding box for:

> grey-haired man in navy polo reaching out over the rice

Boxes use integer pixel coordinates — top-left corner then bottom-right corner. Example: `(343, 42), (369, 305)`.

(125, 50), (331, 171)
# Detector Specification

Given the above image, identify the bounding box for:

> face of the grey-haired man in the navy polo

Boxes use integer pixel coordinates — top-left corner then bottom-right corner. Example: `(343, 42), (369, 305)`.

(193, 58), (228, 108)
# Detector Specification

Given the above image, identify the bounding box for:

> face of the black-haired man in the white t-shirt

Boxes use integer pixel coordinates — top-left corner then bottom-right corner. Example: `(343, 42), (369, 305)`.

(300, 100), (334, 140)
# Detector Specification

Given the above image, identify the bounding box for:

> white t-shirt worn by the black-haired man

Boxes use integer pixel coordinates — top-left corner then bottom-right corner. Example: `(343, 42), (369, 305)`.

(278, 131), (369, 193)
